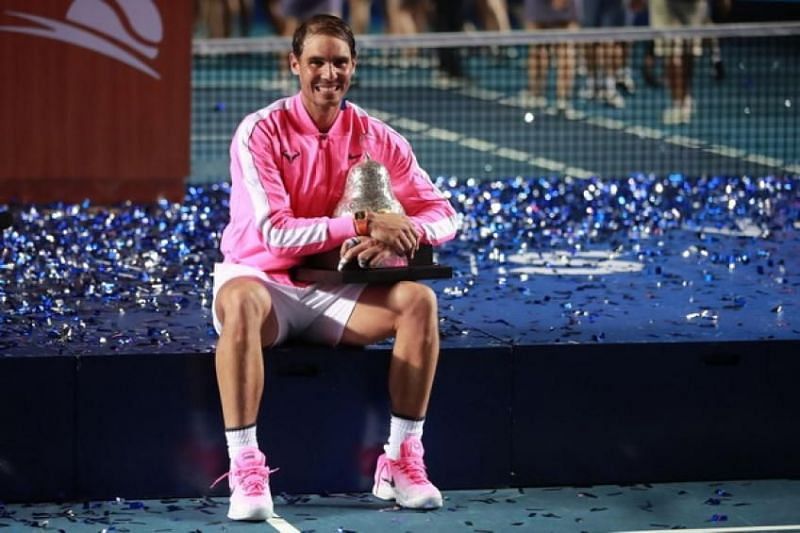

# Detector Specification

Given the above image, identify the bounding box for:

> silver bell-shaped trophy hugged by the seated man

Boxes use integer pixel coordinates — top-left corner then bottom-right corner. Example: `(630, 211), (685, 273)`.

(333, 158), (408, 268)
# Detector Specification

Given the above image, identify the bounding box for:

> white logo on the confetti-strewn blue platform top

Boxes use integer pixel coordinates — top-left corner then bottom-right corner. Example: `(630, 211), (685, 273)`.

(508, 250), (644, 276)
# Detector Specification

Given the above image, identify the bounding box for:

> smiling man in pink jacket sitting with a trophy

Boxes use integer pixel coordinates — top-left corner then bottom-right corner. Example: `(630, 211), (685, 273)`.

(213, 15), (457, 520)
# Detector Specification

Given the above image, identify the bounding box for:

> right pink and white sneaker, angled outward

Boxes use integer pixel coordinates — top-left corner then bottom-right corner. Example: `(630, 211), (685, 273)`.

(372, 437), (442, 509)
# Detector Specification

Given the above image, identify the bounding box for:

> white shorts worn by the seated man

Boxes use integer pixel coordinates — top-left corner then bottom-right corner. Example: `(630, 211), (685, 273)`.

(211, 263), (366, 346)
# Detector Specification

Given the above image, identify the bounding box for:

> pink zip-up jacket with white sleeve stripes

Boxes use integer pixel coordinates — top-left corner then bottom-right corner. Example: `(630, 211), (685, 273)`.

(220, 94), (457, 285)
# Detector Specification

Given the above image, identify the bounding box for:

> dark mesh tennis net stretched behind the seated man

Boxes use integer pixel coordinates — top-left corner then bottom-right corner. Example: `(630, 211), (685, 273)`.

(191, 23), (800, 183)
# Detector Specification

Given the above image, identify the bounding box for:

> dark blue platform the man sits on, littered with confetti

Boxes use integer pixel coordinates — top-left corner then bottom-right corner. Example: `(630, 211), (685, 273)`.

(0, 176), (800, 502)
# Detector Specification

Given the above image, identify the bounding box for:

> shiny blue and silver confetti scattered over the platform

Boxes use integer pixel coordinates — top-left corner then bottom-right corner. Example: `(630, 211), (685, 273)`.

(0, 174), (800, 353)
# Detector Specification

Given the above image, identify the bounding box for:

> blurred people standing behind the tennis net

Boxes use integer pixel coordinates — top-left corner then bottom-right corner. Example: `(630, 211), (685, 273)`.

(195, 0), (800, 125)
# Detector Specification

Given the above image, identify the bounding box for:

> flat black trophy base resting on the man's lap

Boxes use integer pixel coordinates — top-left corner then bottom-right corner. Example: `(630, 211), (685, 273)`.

(292, 244), (453, 283)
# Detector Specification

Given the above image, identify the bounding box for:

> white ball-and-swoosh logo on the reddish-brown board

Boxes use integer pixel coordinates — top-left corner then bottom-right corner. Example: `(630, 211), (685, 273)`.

(0, 0), (164, 79)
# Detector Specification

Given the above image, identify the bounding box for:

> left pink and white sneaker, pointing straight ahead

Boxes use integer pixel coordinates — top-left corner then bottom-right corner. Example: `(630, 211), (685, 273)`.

(211, 447), (277, 520)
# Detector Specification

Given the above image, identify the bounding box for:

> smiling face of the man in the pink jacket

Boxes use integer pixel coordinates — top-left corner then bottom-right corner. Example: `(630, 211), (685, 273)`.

(289, 33), (356, 131)
